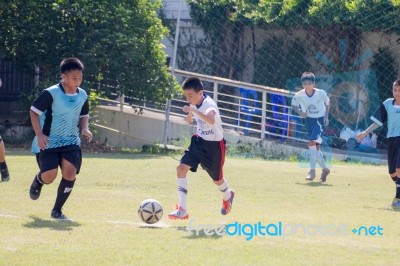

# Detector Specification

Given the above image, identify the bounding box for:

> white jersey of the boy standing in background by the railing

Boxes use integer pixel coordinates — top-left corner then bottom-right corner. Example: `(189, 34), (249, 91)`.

(292, 88), (329, 118)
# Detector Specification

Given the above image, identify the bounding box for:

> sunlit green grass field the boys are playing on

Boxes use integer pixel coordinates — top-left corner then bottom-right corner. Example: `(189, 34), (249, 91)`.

(0, 151), (400, 265)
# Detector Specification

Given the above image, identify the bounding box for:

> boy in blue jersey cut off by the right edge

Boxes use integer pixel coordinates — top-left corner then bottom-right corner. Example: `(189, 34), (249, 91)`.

(357, 79), (400, 210)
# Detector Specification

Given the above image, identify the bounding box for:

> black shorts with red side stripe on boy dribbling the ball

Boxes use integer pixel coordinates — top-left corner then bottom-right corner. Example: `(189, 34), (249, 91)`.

(181, 135), (226, 181)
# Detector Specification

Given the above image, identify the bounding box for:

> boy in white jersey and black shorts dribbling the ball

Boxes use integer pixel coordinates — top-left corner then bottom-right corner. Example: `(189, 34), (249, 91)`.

(168, 77), (235, 220)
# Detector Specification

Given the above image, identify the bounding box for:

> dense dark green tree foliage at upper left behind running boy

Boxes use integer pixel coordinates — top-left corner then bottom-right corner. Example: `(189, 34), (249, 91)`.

(0, 0), (178, 101)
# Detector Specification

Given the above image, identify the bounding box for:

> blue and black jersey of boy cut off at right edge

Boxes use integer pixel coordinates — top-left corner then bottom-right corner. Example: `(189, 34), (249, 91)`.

(371, 98), (400, 138)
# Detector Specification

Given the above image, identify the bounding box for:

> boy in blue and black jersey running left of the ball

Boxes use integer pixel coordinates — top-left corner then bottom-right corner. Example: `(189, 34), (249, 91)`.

(29, 58), (92, 219)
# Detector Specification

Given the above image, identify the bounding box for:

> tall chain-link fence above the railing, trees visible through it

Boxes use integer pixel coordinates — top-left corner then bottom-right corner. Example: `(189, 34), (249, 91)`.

(160, 0), (400, 152)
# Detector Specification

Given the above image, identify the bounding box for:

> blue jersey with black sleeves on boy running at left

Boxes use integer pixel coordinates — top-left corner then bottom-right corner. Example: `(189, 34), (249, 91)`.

(31, 83), (89, 149)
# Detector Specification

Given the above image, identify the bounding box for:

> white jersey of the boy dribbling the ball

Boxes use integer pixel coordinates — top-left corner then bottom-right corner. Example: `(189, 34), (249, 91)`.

(191, 95), (224, 141)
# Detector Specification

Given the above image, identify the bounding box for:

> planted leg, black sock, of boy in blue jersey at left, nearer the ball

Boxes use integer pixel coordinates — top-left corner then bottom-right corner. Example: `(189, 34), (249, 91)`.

(51, 150), (82, 219)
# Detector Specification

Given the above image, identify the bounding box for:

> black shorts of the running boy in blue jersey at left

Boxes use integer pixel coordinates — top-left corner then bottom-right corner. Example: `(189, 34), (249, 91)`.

(38, 146), (82, 174)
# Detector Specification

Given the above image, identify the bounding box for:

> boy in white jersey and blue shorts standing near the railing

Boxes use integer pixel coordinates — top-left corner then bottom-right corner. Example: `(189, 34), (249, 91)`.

(292, 72), (330, 182)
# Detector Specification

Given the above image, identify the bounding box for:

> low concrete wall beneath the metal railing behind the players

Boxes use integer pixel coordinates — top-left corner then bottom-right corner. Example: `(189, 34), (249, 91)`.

(92, 106), (386, 164)
